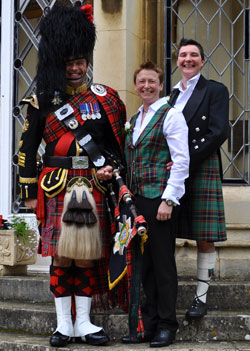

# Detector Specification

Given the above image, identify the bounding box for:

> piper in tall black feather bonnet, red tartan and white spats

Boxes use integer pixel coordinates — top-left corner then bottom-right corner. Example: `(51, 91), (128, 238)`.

(19, 3), (127, 347)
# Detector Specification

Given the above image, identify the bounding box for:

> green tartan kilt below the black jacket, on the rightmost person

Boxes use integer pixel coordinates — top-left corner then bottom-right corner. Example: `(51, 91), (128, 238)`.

(178, 153), (227, 242)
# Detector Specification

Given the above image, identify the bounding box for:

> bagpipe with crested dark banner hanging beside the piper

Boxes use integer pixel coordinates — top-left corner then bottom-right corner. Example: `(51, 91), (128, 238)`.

(104, 155), (148, 339)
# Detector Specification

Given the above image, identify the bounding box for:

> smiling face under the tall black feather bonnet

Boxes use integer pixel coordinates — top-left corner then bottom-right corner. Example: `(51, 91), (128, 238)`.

(66, 59), (88, 88)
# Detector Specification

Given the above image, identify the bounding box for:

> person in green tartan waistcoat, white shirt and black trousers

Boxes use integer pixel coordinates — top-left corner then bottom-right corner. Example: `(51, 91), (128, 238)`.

(122, 61), (189, 347)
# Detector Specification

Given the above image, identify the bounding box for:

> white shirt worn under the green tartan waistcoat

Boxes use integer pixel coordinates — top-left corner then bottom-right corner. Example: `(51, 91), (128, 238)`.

(132, 97), (189, 205)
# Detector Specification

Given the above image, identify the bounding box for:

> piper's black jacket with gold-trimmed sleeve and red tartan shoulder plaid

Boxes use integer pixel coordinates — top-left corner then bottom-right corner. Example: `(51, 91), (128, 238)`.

(18, 85), (126, 200)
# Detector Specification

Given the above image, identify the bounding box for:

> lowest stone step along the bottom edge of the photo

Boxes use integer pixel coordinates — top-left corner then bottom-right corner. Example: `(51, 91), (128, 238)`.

(0, 332), (250, 351)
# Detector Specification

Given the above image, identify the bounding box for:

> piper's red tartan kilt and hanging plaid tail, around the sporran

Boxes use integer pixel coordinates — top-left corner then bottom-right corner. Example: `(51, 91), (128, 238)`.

(38, 169), (127, 311)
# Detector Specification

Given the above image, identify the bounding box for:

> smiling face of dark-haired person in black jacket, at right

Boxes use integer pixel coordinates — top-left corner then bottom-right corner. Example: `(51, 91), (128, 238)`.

(177, 45), (205, 80)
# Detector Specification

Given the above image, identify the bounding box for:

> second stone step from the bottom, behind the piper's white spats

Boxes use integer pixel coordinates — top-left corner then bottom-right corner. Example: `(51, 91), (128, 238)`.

(0, 301), (250, 341)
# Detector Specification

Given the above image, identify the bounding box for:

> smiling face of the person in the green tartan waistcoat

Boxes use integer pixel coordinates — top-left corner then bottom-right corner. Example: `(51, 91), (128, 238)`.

(135, 69), (163, 106)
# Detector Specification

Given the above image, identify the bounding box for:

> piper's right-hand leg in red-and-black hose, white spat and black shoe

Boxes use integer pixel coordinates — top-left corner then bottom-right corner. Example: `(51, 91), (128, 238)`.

(71, 260), (109, 345)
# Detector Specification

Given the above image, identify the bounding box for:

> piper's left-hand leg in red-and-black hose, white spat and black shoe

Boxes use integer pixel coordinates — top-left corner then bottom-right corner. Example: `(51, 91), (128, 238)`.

(50, 257), (74, 347)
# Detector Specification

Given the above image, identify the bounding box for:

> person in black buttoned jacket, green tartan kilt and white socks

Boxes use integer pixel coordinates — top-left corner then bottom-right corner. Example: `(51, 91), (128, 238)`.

(172, 39), (229, 319)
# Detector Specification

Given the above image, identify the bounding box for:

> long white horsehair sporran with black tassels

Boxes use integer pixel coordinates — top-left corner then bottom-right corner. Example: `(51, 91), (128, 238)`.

(58, 177), (102, 260)
